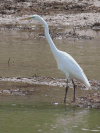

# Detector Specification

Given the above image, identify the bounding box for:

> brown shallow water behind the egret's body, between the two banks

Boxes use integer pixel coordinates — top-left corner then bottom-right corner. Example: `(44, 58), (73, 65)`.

(0, 28), (100, 79)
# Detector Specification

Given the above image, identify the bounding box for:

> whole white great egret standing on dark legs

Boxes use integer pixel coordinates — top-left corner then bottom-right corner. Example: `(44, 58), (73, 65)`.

(21, 15), (90, 103)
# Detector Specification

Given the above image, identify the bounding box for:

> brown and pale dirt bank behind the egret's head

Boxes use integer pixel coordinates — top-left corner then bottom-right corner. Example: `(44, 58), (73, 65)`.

(0, 0), (100, 39)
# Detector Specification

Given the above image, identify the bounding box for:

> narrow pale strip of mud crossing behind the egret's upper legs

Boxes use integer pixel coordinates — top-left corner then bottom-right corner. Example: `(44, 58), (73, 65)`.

(0, 76), (100, 90)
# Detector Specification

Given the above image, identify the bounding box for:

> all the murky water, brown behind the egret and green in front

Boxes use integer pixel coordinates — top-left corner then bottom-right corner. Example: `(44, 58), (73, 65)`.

(0, 30), (100, 133)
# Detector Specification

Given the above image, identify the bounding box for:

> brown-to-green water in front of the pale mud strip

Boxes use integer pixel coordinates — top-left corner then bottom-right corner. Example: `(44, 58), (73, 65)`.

(0, 81), (100, 133)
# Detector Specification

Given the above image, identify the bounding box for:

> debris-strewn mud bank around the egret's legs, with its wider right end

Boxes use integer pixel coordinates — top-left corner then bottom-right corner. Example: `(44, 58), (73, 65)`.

(0, 76), (100, 108)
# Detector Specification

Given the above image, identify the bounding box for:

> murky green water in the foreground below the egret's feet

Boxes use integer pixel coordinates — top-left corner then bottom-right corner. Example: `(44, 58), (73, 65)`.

(0, 102), (100, 133)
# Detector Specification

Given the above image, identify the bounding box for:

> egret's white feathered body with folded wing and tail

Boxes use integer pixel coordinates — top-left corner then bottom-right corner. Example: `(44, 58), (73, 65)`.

(57, 51), (89, 87)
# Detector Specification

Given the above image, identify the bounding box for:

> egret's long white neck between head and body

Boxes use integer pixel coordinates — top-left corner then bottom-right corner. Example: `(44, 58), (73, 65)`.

(41, 19), (58, 56)
